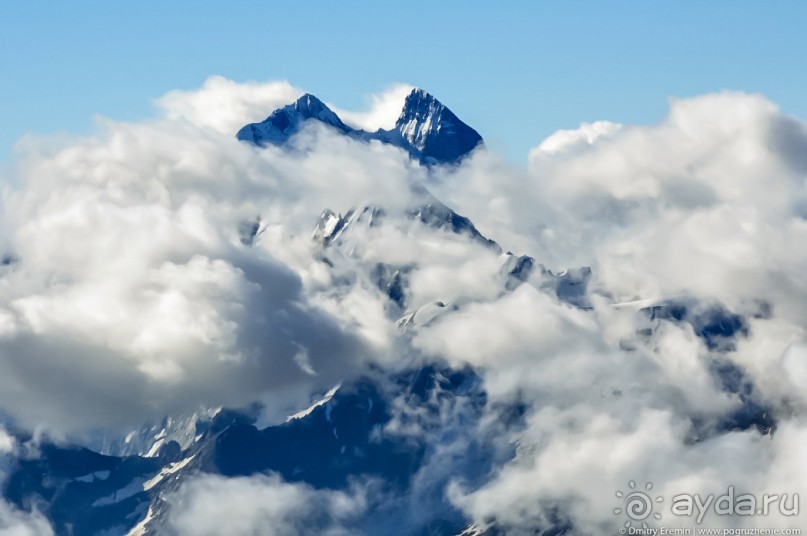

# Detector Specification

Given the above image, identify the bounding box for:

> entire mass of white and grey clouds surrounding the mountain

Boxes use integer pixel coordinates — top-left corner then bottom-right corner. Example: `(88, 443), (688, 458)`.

(0, 78), (807, 535)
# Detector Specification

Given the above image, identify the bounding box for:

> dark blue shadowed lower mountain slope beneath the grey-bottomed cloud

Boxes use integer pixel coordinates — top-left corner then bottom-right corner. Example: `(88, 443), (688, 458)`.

(2, 365), (492, 535)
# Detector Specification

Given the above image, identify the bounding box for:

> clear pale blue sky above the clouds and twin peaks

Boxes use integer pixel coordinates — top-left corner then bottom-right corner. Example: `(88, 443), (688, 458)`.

(0, 0), (807, 163)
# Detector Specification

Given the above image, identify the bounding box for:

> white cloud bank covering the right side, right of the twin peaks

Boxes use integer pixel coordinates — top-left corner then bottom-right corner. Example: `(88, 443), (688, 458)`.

(416, 93), (807, 534)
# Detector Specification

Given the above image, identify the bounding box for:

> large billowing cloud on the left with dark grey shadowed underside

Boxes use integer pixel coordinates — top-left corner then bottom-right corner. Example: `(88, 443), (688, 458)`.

(0, 79), (420, 429)
